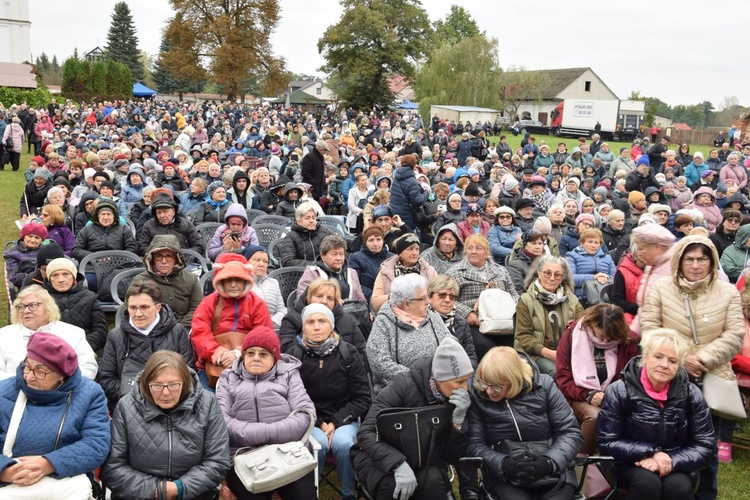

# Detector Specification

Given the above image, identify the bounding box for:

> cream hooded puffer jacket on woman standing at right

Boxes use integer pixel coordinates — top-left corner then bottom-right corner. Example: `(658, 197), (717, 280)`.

(640, 236), (745, 380)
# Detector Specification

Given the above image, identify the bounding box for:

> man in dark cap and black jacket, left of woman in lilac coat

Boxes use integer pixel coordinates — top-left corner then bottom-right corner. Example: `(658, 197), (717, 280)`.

(138, 188), (206, 255)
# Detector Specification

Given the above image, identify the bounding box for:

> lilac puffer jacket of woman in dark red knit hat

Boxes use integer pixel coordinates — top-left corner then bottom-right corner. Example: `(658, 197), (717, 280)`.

(216, 354), (317, 462)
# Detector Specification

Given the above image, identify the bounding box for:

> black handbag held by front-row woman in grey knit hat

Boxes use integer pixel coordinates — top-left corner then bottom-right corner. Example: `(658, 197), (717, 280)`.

(376, 405), (453, 470)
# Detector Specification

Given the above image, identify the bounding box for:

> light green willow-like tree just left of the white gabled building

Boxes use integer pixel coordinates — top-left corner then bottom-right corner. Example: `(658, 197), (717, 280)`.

(414, 35), (501, 116)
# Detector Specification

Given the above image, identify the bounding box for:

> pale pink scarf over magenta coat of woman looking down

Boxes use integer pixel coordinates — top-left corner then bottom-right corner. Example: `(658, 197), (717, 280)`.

(570, 321), (619, 391)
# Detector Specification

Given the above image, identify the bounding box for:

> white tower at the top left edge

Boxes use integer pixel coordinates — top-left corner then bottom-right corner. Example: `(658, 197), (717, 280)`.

(0, 0), (33, 63)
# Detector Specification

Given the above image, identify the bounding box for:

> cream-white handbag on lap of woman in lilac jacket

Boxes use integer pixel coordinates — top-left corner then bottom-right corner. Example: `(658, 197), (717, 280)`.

(234, 408), (318, 493)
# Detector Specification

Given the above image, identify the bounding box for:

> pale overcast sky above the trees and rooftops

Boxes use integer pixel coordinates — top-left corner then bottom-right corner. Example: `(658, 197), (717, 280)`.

(29, 0), (750, 109)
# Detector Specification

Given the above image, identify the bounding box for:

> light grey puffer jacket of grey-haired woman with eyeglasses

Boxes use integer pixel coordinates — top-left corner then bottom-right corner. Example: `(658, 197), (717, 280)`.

(367, 302), (449, 394)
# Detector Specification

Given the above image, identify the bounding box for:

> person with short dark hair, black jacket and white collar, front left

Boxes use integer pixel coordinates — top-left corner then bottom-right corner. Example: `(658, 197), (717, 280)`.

(96, 279), (193, 410)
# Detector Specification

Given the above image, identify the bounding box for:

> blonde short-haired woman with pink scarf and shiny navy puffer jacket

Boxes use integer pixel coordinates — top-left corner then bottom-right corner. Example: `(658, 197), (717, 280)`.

(597, 330), (726, 500)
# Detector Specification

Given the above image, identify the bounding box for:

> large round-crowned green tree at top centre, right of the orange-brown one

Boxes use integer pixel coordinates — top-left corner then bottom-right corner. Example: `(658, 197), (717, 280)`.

(318, 0), (433, 110)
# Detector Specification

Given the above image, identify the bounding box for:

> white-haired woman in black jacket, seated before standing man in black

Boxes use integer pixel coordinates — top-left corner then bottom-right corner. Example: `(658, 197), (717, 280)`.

(281, 202), (332, 267)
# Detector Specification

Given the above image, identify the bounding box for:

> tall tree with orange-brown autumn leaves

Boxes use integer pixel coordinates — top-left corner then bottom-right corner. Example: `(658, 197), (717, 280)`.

(160, 0), (288, 100)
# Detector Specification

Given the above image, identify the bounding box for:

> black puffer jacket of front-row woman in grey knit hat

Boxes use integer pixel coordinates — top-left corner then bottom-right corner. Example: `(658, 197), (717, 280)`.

(351, 357), (468, 491)
